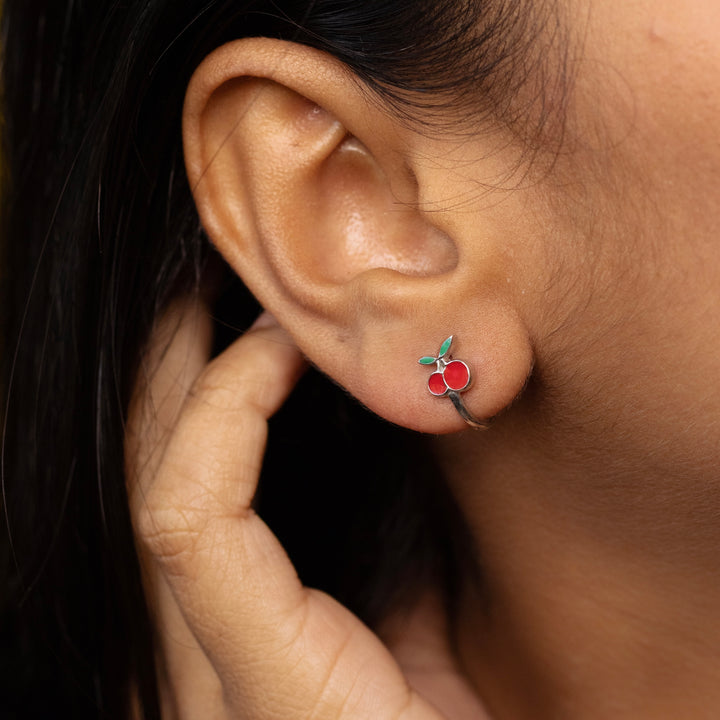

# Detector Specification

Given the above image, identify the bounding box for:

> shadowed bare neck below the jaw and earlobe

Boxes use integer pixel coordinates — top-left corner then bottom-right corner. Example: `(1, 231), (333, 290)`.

(439, 414), (720, 720)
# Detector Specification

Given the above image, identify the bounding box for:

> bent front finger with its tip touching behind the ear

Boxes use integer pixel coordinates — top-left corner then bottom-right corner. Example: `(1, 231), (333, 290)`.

(136, 316), (438, 720)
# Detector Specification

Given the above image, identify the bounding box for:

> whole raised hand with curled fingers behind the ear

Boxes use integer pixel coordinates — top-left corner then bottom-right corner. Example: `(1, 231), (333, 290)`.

(126, 296), (486, 720)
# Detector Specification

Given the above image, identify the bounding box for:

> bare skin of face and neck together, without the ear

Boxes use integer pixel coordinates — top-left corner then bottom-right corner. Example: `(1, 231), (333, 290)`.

(440, 2), (720, 718)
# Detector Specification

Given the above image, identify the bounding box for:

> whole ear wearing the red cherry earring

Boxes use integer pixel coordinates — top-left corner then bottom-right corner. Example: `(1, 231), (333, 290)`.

(183, 38), (532, 433)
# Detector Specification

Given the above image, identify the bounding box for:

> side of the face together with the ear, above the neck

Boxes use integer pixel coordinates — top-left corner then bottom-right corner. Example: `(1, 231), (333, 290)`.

(185, 7), (720, 477)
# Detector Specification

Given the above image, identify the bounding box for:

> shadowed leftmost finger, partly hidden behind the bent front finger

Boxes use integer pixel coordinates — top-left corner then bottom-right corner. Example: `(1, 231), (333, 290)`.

(125, 298), (224, 720)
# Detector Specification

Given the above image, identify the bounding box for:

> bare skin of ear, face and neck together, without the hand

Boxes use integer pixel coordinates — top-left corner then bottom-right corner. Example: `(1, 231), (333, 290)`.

(129, 1), (720, 720)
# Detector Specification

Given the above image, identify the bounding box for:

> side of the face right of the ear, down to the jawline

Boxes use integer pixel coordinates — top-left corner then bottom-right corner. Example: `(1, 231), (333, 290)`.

(512, 0), (720, 478)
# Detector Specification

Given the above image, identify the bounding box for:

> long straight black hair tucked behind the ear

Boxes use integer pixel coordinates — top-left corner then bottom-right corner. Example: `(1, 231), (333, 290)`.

(0, 0), (552, 720)
